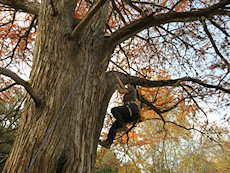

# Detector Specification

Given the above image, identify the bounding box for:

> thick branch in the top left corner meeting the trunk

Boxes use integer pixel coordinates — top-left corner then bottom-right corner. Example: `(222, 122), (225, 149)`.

(0, 0), (40, 15)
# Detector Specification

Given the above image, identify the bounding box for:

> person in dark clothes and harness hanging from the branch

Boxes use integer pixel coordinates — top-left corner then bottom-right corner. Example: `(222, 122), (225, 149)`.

(99, 73), (140, 149)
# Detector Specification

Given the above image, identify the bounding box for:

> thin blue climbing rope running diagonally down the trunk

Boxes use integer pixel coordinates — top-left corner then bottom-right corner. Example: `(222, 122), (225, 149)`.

(27, 36), (106, 173)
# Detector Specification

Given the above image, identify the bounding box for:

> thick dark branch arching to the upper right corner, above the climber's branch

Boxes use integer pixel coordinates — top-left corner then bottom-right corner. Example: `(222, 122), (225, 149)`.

(109, 0), (230, 45)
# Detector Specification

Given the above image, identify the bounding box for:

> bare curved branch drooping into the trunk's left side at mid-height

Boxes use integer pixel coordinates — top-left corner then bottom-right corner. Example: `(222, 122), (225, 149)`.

(0, 68), (41, 105)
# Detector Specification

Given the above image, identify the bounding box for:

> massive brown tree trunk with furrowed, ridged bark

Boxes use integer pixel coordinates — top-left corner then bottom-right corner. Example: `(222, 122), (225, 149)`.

(3, 0), (112, 173)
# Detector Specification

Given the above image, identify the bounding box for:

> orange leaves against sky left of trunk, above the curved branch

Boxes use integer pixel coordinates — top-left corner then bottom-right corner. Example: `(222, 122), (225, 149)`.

(0, 8), (35, 67)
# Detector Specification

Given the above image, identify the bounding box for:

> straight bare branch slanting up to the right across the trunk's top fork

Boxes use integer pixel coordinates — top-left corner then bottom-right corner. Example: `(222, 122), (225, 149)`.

(71, 0), (106, 37)
